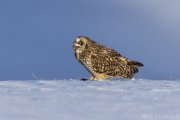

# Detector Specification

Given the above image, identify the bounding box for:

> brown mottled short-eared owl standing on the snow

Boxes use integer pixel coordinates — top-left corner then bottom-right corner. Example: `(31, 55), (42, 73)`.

(73, 36), (143, 80)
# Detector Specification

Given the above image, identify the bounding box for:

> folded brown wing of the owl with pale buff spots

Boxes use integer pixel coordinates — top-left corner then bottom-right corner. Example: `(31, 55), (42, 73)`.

(91, 49), (138, 78)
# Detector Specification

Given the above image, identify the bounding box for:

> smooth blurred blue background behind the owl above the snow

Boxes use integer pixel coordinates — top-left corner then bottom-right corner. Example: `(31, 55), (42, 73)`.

(0, 0), (180, 80)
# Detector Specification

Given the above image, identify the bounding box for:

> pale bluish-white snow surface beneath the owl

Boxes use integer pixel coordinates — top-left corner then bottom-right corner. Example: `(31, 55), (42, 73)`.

(0, 80), (180, 120)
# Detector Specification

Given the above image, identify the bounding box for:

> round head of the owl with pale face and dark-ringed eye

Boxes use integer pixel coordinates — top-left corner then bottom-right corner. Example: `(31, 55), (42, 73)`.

(73, 36), (96, 53)
